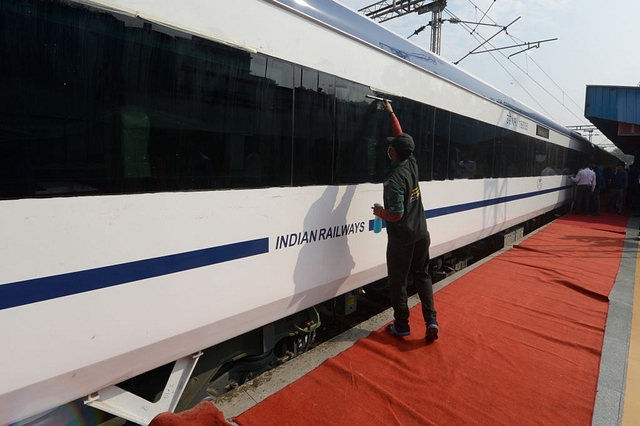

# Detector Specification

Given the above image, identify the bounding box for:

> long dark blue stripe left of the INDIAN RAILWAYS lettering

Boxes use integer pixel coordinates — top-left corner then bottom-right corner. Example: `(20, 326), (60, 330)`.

(0, 238), (269, 310)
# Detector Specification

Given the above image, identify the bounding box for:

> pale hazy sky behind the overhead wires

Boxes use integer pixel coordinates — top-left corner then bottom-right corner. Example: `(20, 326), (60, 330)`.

(338, 0), (640, 149)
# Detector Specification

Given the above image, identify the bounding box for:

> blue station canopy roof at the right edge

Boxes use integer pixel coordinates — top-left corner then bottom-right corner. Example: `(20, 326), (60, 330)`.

(584, 86), (640, 155)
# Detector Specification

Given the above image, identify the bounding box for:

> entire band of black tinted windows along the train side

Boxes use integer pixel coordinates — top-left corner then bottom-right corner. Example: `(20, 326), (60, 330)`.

(0, 0), (586, 198)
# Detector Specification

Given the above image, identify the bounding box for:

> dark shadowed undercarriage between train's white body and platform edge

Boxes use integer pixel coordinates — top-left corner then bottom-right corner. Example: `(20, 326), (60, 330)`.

(30, 205), (570, 426)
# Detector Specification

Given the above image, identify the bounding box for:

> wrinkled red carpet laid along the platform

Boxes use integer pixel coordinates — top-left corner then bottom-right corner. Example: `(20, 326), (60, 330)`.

(234, 214), (628, 426)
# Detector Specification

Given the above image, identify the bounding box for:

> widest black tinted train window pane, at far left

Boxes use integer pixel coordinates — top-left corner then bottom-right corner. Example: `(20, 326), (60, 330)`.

(0, 1), (293, 197)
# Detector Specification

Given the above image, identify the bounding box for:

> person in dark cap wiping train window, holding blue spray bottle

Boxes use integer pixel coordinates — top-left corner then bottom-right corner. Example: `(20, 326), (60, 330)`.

(372, 99), (439, 343)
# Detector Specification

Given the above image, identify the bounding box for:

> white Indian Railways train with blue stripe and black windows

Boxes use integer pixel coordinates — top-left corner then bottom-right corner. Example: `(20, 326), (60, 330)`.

(0, 0), (616, 425)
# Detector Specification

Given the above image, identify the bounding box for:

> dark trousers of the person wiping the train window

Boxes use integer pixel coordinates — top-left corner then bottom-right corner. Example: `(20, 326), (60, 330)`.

(387, 232), (437, 331)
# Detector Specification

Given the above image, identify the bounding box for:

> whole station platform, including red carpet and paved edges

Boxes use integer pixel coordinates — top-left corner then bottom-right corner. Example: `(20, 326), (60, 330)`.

(151, 213), (640, 426)
